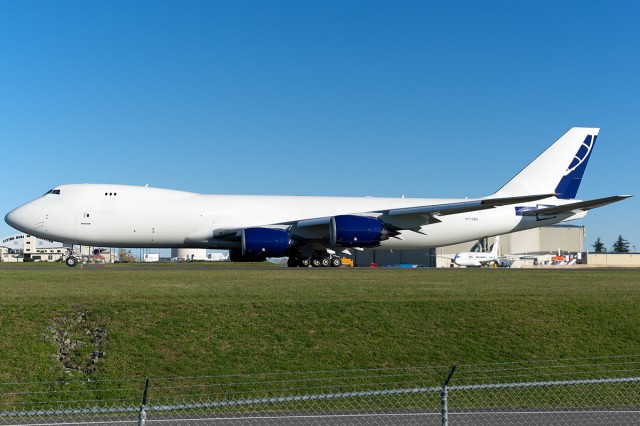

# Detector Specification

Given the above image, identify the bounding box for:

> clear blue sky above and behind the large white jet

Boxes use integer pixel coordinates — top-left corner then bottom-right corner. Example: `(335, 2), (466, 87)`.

(0, 0), (640, 250)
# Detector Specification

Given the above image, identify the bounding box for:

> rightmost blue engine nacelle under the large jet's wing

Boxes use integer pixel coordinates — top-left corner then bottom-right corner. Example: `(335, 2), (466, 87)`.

(329, 215), (388, 247)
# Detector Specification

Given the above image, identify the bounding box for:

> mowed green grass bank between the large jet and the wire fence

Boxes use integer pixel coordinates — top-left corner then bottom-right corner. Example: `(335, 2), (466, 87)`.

(0, 264), (640, 382)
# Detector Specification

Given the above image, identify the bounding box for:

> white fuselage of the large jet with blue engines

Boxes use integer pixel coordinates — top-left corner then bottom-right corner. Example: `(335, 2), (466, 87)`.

(6, 184), (584, 249)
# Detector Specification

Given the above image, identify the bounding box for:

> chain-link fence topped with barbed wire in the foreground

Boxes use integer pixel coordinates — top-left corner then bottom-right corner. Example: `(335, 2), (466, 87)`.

(0, 356), (640, 425)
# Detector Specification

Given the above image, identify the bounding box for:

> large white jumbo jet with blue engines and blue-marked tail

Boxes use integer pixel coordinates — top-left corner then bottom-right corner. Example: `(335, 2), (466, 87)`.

(5, 127), (630, 266)
